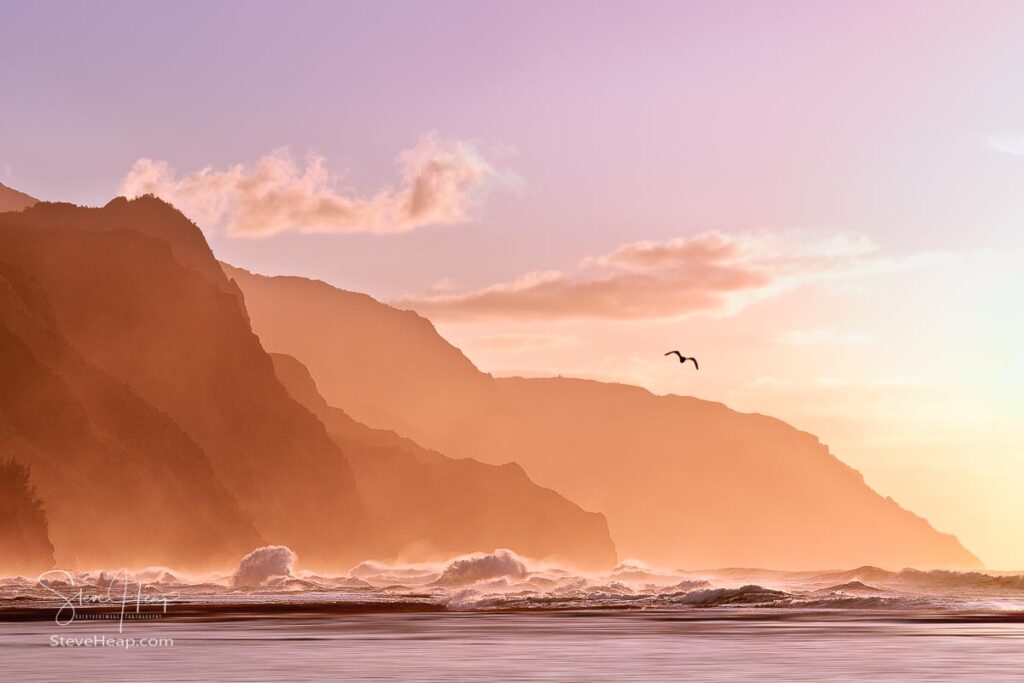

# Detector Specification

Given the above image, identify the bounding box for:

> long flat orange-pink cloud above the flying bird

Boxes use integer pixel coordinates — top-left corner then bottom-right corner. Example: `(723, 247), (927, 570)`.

(395, 232), (884, 321)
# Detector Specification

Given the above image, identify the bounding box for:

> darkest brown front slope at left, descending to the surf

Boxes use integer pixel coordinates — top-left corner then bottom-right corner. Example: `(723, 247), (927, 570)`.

(0, 259), (261, 568)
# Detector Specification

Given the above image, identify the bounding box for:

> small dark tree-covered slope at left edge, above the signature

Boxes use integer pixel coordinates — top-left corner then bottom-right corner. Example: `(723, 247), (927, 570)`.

(0, 459), (53, 574)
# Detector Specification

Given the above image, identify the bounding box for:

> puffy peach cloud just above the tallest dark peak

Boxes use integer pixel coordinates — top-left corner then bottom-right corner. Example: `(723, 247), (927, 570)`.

(121, 134), (497, 238)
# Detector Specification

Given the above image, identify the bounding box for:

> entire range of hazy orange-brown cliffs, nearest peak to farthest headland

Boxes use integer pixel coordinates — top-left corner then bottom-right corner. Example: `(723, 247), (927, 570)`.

(0, 191), (978, 568)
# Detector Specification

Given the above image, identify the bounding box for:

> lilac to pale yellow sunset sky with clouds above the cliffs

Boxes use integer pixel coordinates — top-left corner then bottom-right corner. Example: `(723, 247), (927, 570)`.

(0, 1), (1024, 569)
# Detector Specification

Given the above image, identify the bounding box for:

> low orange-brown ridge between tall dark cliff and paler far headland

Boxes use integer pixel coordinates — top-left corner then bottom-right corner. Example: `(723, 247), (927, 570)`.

(271, 353), (615, 568)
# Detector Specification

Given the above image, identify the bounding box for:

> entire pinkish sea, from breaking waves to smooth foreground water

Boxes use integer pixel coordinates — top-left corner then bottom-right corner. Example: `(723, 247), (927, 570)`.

(0, 551), (1024, 682)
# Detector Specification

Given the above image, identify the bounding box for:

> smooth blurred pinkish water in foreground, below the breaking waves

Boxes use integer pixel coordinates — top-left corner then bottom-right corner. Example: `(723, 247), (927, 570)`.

(0, 608), (1024, 683)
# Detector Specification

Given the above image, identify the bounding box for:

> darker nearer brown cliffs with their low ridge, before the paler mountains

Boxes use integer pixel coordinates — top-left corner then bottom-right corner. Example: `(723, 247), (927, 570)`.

(0, 193), (615, 568)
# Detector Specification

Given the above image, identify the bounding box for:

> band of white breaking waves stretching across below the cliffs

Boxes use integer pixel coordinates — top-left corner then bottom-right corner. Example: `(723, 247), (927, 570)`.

(6, 546), (1024, 618)
